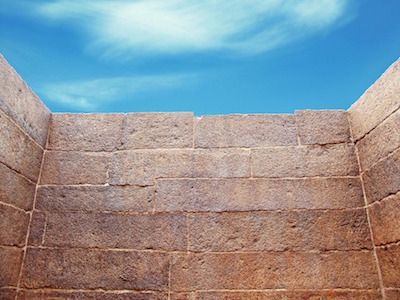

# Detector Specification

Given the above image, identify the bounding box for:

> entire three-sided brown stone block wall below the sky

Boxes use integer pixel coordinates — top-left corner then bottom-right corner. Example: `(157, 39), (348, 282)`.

(0, 54), (400, 300)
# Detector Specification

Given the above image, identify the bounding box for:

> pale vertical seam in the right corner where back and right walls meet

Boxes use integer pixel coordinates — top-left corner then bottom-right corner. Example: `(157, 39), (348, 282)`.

(347, 113), (386, 300)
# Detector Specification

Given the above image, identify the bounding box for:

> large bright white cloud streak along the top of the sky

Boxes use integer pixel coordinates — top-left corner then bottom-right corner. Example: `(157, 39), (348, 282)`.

(37, 0), (351, 58)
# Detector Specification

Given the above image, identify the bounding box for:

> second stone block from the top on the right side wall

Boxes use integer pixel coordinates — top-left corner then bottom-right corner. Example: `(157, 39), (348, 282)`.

(357, 109), (400, 170)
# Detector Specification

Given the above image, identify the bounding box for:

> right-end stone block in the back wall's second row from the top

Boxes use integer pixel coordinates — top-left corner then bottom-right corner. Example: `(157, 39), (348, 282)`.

(251, 144), (359, 178)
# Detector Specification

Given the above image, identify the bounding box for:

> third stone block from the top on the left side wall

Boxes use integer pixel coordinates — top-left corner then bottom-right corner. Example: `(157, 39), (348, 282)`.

(0, 163), (35, 210)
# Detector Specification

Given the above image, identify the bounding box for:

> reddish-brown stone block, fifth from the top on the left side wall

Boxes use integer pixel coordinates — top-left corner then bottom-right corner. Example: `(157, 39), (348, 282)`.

(0, 246), (22, 287)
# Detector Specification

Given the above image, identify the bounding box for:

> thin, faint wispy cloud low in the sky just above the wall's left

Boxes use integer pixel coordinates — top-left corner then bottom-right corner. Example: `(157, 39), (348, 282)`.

(38, 74), (197, 111)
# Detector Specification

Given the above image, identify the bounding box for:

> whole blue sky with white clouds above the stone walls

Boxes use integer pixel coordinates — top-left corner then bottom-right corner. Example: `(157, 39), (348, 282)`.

(0, 0), (400, 115)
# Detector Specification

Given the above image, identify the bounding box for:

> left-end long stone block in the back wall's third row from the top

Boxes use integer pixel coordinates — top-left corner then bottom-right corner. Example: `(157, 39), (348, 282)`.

(36, 186), (154, 212)
